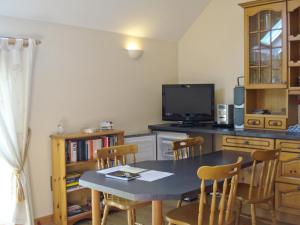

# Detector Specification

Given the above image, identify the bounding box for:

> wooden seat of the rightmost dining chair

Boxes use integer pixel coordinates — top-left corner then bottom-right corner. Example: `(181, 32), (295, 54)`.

(236, 183), (273, 204)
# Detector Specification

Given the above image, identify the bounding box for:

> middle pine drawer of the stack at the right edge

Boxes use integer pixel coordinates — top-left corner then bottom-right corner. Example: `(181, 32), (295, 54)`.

(277, 152), (300, 185)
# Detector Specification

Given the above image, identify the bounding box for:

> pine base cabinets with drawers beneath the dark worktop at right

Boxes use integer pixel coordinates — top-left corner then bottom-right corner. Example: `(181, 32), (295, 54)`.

(223, 135), (300, 224)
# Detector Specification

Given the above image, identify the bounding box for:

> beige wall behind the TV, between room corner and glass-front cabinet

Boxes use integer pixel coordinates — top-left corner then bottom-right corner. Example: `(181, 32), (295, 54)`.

(178, 0), (248, 103)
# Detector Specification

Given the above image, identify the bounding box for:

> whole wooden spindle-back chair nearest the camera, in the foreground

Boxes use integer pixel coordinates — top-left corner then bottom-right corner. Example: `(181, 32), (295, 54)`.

(167, 157), (243, 225)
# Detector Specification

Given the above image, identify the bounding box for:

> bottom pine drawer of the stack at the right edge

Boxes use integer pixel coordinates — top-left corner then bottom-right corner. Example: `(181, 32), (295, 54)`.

(275, 183), (300, 215)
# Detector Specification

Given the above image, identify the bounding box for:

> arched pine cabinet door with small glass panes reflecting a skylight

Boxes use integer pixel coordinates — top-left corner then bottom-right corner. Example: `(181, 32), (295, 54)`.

(245, 2), (287, 88)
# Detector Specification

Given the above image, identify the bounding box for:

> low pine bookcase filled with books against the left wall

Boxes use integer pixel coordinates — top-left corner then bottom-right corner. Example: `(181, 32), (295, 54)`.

(50, 130), (124, 225)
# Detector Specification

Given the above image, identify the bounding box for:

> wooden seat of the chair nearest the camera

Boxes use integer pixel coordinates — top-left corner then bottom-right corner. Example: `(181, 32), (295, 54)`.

(166, 202), (234, 225)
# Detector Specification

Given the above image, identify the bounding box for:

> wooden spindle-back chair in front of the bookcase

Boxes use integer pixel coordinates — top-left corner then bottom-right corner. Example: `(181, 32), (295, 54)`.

(97, 144), (151, 225)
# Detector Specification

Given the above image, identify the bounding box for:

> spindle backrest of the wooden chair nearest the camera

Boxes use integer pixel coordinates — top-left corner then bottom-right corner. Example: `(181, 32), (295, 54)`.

(197, 157), (243, 225)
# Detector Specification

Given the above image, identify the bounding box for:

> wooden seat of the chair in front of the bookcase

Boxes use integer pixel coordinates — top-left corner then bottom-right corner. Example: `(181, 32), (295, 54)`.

(103, 195), (151, 210)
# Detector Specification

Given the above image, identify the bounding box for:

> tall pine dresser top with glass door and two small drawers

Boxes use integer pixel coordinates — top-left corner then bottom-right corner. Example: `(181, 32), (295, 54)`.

(240, 0), (300, 130)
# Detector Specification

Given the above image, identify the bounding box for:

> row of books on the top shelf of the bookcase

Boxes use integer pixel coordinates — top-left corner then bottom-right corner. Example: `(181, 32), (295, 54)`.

(66, 135), (118, 163)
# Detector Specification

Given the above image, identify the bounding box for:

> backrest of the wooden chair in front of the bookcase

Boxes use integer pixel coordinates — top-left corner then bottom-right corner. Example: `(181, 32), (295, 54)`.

(97, 144), (138, 169)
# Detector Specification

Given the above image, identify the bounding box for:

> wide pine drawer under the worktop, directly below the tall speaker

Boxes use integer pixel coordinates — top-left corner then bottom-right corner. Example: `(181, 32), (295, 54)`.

(223, 135), (275, 150)
